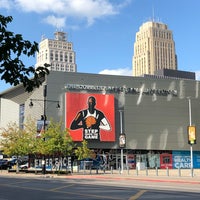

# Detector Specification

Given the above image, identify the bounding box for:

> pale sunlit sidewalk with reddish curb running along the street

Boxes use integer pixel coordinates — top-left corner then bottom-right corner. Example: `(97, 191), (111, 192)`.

(0, 169), (200, 184)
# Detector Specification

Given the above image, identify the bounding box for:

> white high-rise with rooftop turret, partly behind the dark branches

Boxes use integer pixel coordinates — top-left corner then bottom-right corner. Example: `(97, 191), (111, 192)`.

(36, 32), (77, 72)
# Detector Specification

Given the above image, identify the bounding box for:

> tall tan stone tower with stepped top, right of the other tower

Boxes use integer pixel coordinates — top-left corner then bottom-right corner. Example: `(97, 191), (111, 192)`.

(132, 21), (177, 76)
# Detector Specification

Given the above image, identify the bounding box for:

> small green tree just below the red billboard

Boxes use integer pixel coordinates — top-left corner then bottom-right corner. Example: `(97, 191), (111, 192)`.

(75, 140), (93, 160)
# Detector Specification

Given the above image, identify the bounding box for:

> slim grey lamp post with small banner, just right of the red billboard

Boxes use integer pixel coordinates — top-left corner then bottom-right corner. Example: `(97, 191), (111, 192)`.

(119, 110), (126, 173)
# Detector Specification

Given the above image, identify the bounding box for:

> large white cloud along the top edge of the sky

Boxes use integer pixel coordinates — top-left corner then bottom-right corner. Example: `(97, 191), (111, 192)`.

(8, 0), (131, 26)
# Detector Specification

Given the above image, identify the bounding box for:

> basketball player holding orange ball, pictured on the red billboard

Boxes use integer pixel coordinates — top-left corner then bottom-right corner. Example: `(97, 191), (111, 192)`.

(70, 96), (111, 140)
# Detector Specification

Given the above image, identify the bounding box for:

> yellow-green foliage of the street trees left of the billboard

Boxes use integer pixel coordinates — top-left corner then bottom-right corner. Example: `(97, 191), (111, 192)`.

(0, 121), (74, 159)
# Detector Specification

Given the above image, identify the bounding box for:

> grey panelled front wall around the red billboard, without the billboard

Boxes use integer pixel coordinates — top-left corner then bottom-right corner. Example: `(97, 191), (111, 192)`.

(42, 73), (200, 150)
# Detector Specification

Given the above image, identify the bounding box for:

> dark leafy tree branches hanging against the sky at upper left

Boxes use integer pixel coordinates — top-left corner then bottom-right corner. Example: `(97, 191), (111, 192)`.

(0, 15), (49, 92)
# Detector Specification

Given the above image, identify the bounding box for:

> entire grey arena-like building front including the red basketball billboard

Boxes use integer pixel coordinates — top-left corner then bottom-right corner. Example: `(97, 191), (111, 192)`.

(0, 72), (200, 168)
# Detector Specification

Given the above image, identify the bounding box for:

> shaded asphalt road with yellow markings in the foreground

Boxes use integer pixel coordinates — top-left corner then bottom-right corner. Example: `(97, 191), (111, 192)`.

(0, 175), (200, 200)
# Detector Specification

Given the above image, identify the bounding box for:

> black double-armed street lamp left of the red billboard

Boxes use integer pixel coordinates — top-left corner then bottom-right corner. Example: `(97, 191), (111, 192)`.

(29, 84), (60, 174)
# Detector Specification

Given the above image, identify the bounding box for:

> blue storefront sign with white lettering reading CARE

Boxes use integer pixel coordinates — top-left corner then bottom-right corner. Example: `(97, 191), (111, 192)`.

(172, 151), (200, 169)
